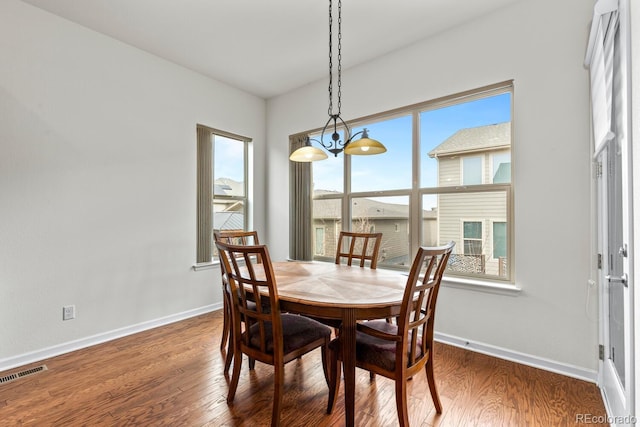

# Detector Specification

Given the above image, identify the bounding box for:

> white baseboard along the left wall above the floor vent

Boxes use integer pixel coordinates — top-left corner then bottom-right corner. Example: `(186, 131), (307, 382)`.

(0, 304), (222, 372)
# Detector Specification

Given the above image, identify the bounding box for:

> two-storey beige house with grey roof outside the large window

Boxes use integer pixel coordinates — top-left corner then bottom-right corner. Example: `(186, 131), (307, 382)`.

(429, 122), (511, 276)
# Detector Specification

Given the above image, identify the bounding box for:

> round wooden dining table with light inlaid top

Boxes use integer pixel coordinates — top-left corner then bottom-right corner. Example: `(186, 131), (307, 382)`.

(273, 261), (407, 426)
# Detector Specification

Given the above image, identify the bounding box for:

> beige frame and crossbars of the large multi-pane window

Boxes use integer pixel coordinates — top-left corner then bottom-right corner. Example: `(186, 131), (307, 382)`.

(308, 80), (516, 290)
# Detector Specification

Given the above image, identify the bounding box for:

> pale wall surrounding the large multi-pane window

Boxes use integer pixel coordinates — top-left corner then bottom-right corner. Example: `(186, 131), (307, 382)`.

(267, 0), (598, 378)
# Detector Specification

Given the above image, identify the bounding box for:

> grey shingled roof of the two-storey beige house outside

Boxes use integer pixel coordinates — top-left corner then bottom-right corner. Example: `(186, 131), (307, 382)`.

(429, 122), (511, 158)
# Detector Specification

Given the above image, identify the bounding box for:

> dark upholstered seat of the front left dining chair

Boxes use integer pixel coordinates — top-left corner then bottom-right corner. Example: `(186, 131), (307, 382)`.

(249, 314), (331, 353)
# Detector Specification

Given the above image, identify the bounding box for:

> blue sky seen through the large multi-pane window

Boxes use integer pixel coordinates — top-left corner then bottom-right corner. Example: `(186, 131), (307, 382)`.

(312, 93), (511, 203)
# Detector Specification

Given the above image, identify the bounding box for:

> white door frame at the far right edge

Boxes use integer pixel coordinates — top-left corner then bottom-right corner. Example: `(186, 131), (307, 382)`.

(594, 0), (640, 426)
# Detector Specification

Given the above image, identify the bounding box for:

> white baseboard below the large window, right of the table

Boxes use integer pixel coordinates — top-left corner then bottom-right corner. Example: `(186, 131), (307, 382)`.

(433, 332), (598, 384)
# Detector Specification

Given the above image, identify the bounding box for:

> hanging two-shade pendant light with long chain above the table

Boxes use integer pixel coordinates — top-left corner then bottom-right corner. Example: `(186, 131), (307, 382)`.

(289, 0), (387, 162)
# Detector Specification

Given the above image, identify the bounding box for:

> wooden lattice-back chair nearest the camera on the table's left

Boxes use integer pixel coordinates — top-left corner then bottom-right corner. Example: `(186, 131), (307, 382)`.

(216, 242), (331, 426)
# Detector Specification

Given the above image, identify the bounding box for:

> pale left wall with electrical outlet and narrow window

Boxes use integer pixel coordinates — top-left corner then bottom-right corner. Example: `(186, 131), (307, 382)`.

(0, 0), (266, 370)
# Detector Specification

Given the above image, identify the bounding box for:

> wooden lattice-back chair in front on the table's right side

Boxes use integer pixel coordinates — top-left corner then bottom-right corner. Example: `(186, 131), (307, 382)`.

(327, 242), (455, 427)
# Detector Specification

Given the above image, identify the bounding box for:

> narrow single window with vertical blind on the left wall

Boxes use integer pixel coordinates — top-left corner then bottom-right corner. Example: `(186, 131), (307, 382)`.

(197, 125), (251, 263)
